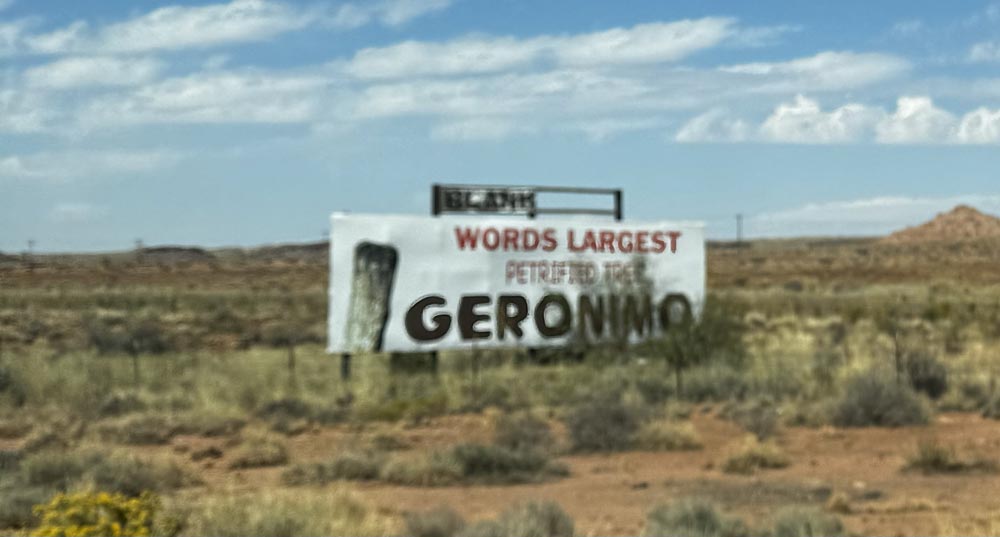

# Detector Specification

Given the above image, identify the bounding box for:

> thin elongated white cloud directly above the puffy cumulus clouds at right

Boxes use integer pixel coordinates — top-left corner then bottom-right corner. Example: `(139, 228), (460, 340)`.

(720, 51), (910, 92)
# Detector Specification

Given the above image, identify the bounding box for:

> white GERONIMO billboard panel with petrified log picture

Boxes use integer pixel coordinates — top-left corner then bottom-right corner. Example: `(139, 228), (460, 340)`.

(329, 214), (705, 353)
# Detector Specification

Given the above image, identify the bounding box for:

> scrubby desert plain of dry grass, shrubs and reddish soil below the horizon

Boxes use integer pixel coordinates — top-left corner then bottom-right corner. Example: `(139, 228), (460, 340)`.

(0, 208), (1000, 537)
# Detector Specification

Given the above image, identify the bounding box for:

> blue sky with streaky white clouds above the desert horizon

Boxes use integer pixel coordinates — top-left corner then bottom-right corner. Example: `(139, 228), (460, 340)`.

(0, 0), (1000, 252)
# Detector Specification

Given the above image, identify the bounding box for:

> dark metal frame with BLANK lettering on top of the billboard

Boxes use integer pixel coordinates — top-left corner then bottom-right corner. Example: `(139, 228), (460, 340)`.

(431, 183), (623, 221)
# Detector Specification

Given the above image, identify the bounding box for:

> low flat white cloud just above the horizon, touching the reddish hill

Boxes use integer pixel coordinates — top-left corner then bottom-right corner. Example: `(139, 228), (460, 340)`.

(746, 194), (1000, 237)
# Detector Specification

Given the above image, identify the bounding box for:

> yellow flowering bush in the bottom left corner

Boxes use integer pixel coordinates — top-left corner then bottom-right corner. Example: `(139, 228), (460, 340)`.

(31, 492), (160, 537)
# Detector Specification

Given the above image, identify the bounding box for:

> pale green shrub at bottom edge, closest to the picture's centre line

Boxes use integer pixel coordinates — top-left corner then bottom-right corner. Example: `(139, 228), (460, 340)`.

(459, 502), (574, 537)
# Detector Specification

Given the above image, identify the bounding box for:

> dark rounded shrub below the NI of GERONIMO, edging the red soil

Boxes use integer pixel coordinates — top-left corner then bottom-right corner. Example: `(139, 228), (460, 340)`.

(564, 393), (642, 452)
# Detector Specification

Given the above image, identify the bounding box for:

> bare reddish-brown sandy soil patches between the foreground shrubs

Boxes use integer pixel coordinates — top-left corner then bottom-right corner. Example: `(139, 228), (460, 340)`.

(151, 413), (1000, 535)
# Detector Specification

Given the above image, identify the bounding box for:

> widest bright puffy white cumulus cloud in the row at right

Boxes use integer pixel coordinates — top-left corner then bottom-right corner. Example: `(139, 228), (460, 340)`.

(760, 95), (881, 144)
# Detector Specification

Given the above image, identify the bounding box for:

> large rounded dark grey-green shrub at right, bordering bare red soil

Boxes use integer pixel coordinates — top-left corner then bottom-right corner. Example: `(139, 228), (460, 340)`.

(832, 373), (930, 427)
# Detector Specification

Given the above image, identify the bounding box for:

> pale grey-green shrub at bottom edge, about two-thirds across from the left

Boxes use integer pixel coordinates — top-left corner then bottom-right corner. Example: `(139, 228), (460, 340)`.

(642, 500), (750, 537)
